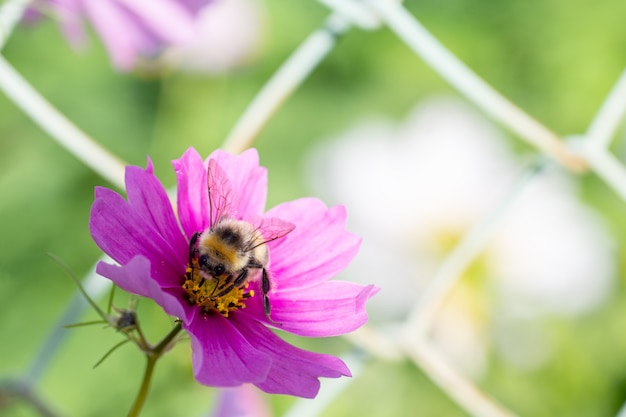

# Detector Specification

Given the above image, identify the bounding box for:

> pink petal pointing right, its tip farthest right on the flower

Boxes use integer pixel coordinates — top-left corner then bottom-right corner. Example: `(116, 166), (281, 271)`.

(242, 281), (379, 337)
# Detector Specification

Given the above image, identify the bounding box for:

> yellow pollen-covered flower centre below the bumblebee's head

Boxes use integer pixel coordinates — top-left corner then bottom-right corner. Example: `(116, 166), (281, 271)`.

(183, 259), (254, 317)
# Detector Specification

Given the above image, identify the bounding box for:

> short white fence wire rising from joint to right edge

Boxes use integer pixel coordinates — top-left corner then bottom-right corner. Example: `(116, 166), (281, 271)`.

(585, 69), (626, 149)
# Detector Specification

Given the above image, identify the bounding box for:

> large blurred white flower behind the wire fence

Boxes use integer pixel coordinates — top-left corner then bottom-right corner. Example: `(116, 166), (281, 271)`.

(308, 98), (614, 371)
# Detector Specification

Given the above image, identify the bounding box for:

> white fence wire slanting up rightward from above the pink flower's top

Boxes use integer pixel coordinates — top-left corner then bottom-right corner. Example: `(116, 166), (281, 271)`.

(222, 14), (350, 153)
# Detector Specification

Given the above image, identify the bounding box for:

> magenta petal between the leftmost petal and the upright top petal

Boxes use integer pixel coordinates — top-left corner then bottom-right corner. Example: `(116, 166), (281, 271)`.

(126, 160), (189, 264)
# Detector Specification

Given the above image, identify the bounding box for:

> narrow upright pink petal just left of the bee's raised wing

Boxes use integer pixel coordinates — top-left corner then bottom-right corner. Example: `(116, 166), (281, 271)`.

(172, 148), (210, 238)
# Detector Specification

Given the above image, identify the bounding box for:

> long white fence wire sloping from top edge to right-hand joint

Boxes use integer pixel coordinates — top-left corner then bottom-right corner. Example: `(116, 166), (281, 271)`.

(367, 0), (586, 172)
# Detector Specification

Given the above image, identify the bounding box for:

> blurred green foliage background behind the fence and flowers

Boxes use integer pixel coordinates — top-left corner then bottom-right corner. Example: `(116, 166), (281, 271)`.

(0, 0), (626, 417)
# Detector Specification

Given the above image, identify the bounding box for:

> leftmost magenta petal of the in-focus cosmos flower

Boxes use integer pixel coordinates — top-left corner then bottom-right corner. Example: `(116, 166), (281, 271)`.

(89, 187), (186, 286)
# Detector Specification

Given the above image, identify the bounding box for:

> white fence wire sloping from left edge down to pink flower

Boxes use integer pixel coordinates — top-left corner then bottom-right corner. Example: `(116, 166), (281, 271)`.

(0, 55), (126, 190)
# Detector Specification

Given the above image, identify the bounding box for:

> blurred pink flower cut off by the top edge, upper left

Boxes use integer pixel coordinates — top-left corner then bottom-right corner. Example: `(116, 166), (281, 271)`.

(33, 0), (212, 70)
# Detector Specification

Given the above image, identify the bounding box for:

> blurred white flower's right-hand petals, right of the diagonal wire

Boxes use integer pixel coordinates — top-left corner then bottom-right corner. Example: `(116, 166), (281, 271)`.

(488, 171), (614, 316)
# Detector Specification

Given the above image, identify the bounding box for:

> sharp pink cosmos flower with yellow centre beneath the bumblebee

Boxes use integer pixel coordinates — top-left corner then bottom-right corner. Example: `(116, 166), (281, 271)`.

(89, 148), (378, 398)
